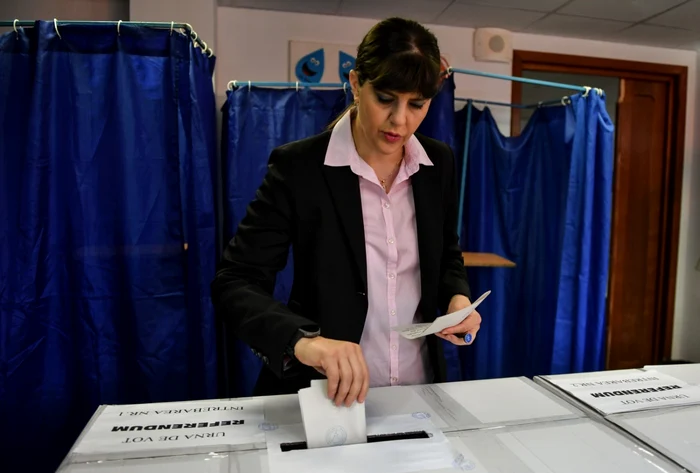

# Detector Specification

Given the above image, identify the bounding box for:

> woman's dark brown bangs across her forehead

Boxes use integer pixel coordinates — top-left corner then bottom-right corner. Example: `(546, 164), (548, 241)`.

(368, 51), (442, 99)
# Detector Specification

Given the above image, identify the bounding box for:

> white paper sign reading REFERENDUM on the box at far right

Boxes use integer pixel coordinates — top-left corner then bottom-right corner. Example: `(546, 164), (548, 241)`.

(545, 370), (700, 414)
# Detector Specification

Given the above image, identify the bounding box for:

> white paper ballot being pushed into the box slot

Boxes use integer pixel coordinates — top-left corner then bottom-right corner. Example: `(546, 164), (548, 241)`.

(299, 380), (367, 448)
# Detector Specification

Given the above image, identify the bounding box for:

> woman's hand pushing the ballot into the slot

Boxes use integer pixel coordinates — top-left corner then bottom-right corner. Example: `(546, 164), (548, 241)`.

(294, 337), (369, 407)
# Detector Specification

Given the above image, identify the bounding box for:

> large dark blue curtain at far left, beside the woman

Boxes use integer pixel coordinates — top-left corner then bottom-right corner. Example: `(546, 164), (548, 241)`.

(0, 22), (216, 471)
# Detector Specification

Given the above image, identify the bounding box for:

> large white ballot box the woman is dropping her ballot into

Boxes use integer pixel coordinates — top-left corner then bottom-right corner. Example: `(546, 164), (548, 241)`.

(59, 370), (700, 473)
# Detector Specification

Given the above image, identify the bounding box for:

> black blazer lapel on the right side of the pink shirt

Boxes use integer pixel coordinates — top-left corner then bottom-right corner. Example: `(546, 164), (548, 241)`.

(411, 165), (442, 320)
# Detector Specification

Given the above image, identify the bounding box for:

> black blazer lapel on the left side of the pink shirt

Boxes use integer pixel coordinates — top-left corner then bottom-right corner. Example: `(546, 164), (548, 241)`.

(323, 166), (367, 294)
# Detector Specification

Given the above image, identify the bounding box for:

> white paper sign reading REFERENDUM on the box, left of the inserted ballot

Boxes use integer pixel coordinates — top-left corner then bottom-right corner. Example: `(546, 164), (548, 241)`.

(71, 399), (267, 461)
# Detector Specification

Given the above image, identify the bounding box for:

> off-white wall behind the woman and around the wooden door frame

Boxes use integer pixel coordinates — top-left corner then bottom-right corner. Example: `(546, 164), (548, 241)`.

(216, 7), (700, 362)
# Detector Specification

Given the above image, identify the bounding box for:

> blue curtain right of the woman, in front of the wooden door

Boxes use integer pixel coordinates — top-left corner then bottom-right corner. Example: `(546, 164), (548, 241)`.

(455, 94), (613, 379)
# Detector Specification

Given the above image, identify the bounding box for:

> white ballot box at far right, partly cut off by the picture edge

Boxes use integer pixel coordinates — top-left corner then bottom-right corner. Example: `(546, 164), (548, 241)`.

(535, 364), (700, 471)
